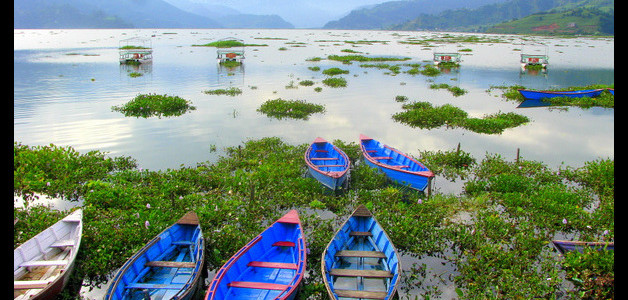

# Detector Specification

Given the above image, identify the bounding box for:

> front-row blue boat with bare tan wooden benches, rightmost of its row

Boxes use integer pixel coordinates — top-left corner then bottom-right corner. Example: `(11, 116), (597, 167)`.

(321, 205), (401, 300)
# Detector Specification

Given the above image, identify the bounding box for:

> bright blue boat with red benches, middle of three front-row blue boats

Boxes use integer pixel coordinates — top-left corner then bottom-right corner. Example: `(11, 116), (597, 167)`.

(205, 210), (307, 300)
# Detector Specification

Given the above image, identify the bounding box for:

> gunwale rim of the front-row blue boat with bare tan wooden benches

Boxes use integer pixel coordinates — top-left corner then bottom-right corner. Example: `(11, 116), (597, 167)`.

(321, 204), (402, 299)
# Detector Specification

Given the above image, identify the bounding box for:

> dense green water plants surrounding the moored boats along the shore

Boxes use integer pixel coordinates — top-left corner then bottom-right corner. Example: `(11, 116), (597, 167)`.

(13, 137), (615, 299)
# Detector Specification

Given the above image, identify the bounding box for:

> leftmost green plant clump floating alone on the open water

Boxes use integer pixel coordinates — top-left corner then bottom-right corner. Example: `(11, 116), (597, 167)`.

(111, 94), (196, 118)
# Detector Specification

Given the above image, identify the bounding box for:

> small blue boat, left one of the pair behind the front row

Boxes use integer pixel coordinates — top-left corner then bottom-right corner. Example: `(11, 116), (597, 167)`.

(305, 137), (349, 190)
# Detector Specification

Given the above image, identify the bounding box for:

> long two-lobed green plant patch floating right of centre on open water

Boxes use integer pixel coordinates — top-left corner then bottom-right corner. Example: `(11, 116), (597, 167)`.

(392, 102), (530, 134)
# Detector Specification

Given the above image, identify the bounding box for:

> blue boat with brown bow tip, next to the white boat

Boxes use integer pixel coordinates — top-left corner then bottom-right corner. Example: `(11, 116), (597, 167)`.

(105, 212), (205, 300)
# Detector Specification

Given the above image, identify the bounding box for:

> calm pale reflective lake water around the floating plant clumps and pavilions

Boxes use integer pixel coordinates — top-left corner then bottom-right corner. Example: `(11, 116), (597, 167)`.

(13, 29), (615, 298)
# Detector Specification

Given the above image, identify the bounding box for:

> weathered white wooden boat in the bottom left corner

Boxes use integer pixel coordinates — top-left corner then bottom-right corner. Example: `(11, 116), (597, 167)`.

(13, 209), (83, 300)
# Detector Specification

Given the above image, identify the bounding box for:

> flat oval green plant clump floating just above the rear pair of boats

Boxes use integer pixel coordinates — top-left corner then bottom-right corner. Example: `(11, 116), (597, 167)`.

(257, 98), (325, 120)
